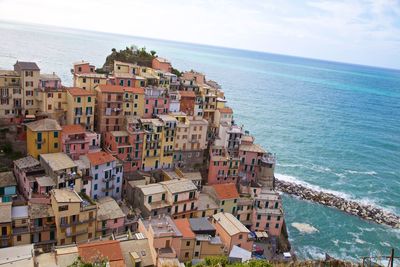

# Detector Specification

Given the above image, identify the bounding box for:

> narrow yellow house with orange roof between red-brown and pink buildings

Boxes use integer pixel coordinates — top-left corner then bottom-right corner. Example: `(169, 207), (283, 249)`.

(123, 87), (144, 118)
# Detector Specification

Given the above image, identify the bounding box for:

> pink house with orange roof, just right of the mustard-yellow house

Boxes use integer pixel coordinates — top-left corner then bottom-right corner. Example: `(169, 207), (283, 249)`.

(61, 124), (101, 160)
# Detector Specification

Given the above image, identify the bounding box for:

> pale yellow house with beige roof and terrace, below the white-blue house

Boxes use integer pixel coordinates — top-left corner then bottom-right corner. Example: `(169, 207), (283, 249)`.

(51, 189), (97, 245)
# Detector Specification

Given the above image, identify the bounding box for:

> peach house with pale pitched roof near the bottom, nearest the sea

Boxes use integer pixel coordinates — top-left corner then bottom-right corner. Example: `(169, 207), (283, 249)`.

(212, 212), (253, 251)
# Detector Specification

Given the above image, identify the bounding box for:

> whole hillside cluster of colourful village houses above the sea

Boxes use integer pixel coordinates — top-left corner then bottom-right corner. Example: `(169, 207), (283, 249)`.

(0, 57), (284, 266)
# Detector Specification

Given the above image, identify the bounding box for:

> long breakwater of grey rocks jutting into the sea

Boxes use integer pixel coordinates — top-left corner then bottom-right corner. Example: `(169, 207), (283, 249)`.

(275, 179), (400, 228)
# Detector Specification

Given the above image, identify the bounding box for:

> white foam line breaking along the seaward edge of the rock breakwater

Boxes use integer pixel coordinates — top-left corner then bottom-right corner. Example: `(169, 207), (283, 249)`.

(275, 173), (397, 214)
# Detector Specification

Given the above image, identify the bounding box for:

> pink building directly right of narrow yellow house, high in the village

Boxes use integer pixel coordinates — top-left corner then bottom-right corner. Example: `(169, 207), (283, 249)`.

(143, 87), (170, 119)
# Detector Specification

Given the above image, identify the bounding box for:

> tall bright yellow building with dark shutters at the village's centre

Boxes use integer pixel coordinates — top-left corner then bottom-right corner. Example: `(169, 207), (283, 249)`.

(140, 115), (177, 171)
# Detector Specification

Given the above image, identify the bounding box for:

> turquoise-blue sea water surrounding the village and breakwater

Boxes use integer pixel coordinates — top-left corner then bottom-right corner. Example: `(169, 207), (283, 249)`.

(0, 22), (400, 260)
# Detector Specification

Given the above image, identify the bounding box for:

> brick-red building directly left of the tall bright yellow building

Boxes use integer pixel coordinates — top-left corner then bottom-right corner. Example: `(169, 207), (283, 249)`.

(104, 119), (144, 173)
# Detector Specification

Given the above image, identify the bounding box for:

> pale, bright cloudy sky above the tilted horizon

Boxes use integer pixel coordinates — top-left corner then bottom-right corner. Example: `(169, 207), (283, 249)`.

(0, 0), (400, 69)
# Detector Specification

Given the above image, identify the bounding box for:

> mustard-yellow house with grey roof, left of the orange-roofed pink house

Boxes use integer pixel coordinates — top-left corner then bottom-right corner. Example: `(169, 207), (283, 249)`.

(26, 119), (62, 159)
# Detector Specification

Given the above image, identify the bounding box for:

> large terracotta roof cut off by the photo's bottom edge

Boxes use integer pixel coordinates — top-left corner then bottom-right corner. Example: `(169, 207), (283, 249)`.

(78, 240), (125, 267)
